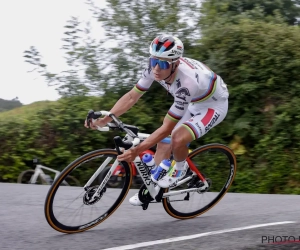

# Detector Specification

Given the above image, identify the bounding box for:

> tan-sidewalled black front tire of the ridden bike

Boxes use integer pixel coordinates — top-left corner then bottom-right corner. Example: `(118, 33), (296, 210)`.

(44, 149), (132, 234)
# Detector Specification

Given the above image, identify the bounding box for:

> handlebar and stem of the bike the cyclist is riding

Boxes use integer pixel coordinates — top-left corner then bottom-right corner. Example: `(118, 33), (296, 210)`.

(86, 110), (140, 154)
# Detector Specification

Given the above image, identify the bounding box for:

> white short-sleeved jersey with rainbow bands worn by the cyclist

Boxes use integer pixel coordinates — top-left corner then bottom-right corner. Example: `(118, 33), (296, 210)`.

(134, 57), (229, 122)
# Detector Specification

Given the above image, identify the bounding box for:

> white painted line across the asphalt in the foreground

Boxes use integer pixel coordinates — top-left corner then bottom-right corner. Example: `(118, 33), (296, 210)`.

(102, 221), (296, 250)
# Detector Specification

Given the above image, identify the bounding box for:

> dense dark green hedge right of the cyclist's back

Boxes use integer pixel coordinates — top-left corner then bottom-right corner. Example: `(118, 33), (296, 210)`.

(194, 18), (300, 193)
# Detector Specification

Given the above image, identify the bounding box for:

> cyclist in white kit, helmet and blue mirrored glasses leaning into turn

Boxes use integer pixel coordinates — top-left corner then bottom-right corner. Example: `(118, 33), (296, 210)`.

(85, 35), (229, 205)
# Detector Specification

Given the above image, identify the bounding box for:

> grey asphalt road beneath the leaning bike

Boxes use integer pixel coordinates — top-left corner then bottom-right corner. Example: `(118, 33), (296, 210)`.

(0, 183), (300, 250)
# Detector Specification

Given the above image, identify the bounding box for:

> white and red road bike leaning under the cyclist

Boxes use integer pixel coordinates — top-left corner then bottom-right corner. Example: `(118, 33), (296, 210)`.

(44, 110), (237, 233)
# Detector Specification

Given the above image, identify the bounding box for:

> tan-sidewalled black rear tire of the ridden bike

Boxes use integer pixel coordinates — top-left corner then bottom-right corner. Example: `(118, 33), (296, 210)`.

(162, 143), (237, 219)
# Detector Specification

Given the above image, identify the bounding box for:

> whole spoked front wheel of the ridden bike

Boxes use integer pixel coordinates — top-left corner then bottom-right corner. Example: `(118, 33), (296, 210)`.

(44, 149), (132, 233)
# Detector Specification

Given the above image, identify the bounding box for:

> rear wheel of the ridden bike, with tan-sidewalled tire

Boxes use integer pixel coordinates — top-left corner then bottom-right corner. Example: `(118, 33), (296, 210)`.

(163, 144), (237, 219)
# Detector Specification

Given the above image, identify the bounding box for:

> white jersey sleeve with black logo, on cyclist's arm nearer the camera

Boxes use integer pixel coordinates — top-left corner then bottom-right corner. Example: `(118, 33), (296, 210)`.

(167, 82), (197, 123)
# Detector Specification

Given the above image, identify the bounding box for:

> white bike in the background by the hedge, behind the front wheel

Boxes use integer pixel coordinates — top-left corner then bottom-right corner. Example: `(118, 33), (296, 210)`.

(17, 159), (79, 186)
